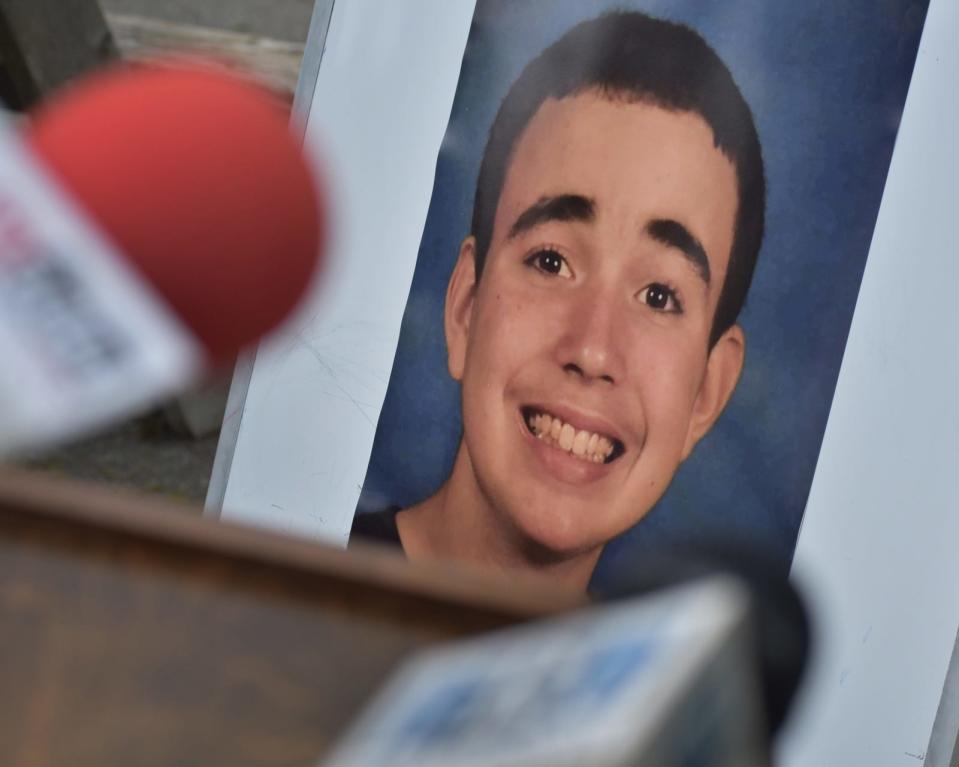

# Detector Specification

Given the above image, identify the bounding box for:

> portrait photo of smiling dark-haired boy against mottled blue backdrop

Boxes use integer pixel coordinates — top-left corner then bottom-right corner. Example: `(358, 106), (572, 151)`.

(351, 0), (925, 589)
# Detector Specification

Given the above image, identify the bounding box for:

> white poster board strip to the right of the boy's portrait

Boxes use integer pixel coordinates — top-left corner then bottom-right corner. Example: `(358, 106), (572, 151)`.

(784, 1), (959, 767)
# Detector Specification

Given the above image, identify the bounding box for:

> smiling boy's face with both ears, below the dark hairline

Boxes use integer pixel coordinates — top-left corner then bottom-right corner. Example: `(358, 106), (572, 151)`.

(446, 93), (744, 554)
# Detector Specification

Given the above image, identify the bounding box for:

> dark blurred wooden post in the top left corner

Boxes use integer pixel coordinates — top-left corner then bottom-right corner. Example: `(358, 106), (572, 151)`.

(0, 0), (117, 109)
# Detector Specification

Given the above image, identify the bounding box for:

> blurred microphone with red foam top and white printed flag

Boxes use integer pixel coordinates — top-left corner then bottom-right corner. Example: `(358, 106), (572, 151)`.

(0, 62), (323, 455)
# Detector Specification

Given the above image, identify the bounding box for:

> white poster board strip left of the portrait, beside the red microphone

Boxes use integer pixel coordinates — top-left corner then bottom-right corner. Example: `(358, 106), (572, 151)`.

(207, 0), (473, 545)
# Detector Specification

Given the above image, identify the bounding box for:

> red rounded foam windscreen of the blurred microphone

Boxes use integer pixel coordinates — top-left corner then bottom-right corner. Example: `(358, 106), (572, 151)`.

(27, 66), (323, 361)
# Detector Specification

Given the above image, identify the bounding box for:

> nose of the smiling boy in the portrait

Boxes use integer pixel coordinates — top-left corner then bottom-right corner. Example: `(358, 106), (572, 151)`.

(558, 291), (624, 384)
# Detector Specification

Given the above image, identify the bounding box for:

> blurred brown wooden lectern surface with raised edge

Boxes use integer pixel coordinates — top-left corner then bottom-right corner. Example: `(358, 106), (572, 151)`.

(0, 472), (581, 767)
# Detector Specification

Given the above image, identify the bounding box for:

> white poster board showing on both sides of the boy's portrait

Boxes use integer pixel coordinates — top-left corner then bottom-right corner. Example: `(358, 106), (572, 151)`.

(208, 0), (959, 767)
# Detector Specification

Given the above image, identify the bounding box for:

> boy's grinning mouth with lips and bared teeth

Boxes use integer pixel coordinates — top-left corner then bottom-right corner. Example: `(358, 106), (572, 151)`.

(520, 405), (625, 464)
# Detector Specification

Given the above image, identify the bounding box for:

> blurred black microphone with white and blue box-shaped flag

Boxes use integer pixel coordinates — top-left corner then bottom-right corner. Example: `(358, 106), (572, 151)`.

(323, 548), (809, 767)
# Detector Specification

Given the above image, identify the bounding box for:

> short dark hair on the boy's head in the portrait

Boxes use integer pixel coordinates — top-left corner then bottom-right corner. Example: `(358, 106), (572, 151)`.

(472, 11), (766, 346)
